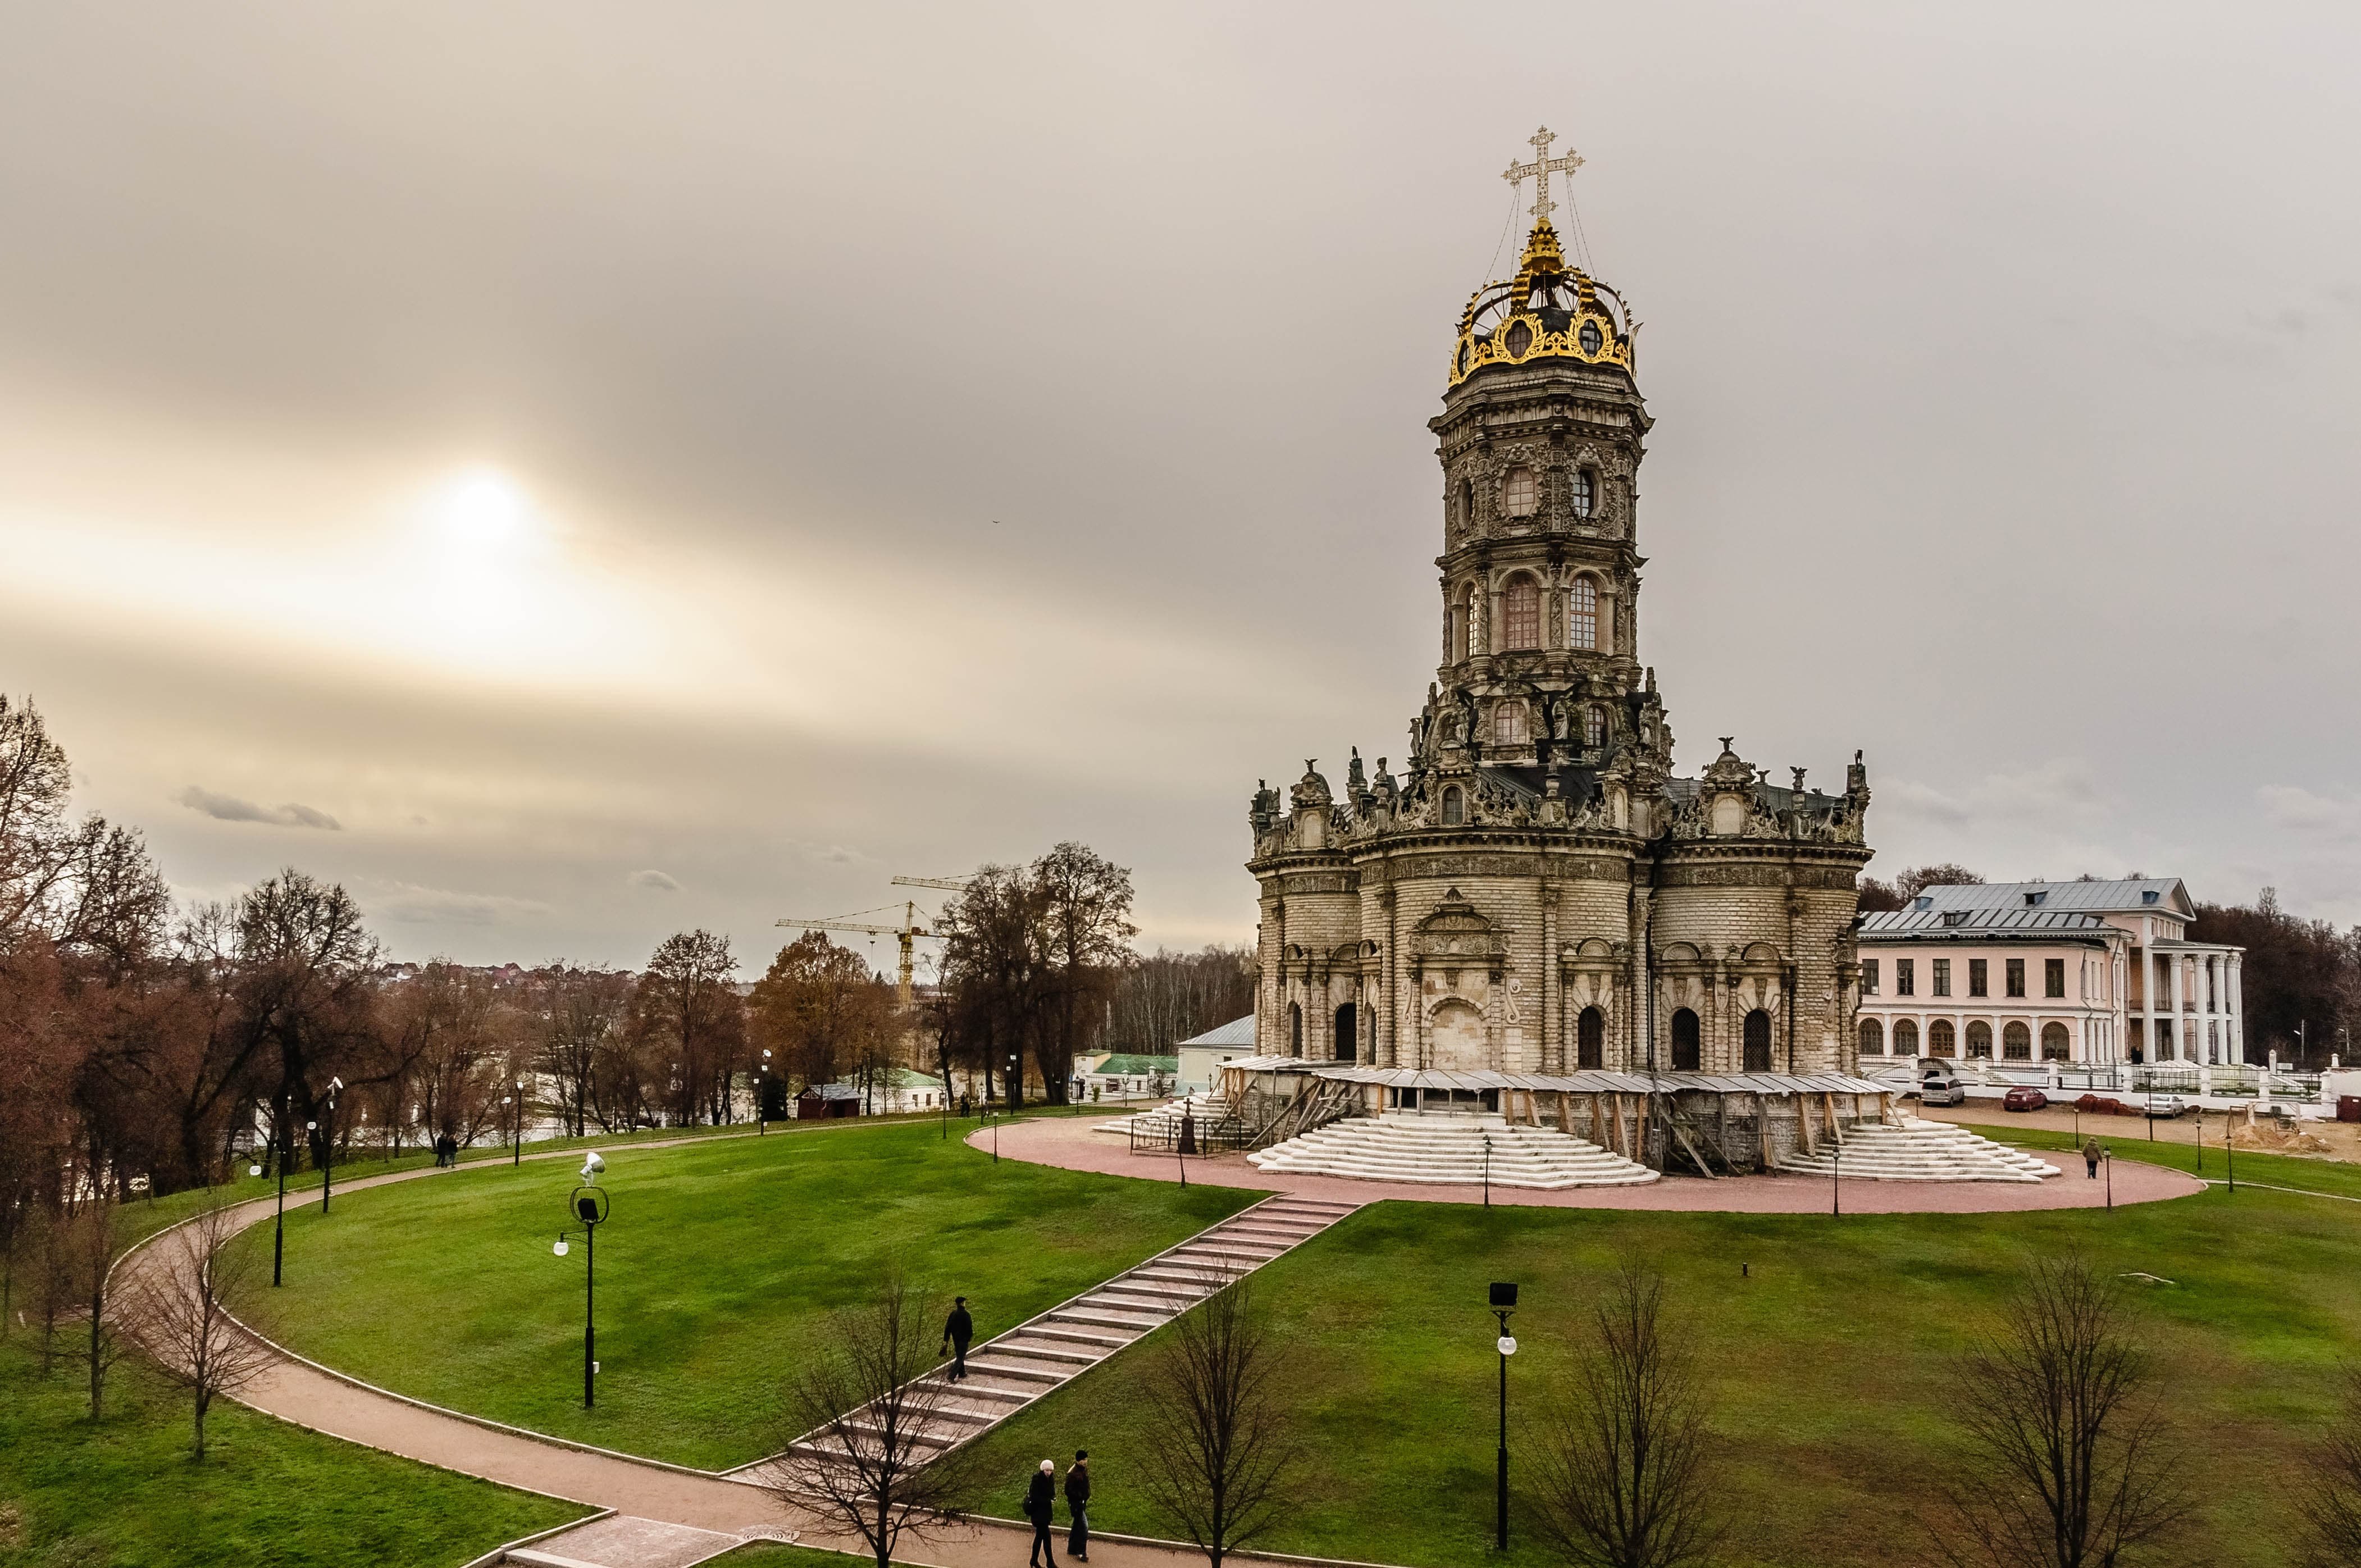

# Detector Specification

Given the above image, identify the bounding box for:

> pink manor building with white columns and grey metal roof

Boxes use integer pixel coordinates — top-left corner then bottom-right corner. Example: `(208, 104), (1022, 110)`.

(1856, 876), (2245, 1068)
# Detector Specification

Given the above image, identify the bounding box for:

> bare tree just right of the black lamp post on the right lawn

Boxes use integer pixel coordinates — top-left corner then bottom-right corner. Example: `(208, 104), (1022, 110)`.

(1530, 1254), (1719, 1568)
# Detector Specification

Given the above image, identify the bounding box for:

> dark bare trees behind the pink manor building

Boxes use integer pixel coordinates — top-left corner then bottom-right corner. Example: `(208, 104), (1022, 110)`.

(1861, 864), (2361, 1068)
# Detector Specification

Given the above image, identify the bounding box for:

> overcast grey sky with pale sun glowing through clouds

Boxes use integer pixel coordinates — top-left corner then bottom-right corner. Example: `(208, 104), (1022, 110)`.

(0, 0), (2361, 966)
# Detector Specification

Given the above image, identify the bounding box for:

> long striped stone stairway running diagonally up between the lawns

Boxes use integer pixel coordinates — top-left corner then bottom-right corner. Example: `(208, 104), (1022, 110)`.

(730, 1192), (1360, 1480)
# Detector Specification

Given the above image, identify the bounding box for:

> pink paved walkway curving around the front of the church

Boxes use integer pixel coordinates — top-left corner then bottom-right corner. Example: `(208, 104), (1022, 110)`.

(968, 1117), (2205, 1214)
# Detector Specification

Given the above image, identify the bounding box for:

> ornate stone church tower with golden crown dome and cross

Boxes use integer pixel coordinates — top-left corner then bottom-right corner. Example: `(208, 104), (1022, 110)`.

(1247, 130), (1870, 1074)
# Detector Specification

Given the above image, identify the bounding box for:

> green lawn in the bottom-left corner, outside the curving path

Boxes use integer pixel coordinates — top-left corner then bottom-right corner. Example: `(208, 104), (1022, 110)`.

(0, 1337), (586, 1568)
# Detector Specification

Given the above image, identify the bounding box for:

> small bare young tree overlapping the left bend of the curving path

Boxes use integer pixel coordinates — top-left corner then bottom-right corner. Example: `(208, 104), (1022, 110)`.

(125, 1204), (271, 1460)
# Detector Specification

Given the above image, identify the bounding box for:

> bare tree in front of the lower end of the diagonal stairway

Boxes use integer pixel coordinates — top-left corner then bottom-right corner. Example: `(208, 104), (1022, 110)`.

(772, 1270), (968, 1568)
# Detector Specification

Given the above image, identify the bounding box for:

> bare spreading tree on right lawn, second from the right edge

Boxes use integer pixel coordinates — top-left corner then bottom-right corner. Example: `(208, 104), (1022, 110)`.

(1936, 1254), (2189, 1568)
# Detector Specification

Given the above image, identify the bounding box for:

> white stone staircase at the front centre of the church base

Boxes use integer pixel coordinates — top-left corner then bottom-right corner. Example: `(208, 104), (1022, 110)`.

(1247, 1112), (1657, 1190)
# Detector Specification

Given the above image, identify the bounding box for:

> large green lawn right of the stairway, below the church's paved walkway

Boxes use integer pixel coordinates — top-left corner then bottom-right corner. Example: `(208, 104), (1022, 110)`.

(958, 1129), (2361, 1568)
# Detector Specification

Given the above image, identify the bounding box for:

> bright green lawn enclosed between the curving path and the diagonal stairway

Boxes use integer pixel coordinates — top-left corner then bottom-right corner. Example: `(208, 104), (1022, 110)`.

(239, 1122), (1256, 1469)
